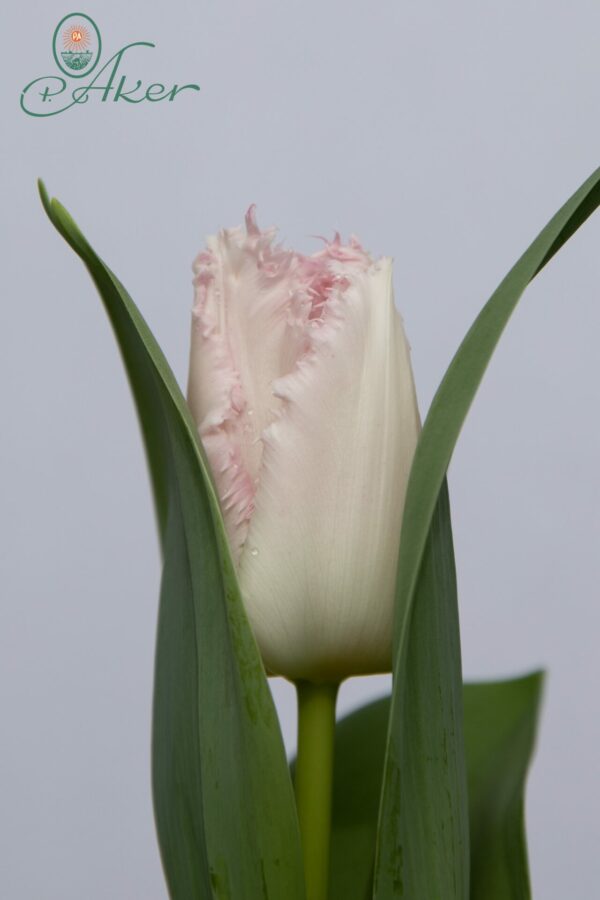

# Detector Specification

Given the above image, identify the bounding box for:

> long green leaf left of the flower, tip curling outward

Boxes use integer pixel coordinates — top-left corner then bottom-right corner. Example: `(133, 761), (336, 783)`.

(40, 183), (304, 900)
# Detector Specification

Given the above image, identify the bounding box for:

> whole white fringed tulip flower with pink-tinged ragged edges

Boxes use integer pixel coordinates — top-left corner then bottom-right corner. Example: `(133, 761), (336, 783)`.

(189, 207), (420, 681)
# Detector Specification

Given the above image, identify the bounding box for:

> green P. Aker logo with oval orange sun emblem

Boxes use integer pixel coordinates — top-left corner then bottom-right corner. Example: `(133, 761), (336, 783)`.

(20, 13), (200, 118)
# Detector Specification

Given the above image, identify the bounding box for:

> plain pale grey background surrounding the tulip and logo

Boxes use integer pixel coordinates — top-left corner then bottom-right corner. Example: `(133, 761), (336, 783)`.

(0, 0), (600, 900)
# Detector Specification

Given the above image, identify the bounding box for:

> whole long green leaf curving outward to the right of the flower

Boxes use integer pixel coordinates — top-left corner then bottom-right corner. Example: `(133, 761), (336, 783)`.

(374, 163), (600, 900)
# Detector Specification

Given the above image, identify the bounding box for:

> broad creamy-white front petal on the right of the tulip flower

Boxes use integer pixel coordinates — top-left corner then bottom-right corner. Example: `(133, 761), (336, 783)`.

(239, 259), (420, 680)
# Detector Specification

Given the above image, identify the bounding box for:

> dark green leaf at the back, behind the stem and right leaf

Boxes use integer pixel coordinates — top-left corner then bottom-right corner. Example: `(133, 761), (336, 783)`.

(330, 672), (542, 900)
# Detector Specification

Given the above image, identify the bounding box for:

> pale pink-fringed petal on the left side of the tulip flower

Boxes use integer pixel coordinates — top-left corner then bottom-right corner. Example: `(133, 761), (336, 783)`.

(188, 208), (306, 559)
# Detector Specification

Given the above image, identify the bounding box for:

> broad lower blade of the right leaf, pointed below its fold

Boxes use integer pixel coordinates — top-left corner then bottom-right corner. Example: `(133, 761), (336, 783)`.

(374, 483), (469, 900)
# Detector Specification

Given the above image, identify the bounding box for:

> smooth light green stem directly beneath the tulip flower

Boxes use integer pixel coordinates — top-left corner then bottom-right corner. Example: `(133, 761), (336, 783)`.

(296, 681), (339, 900)
